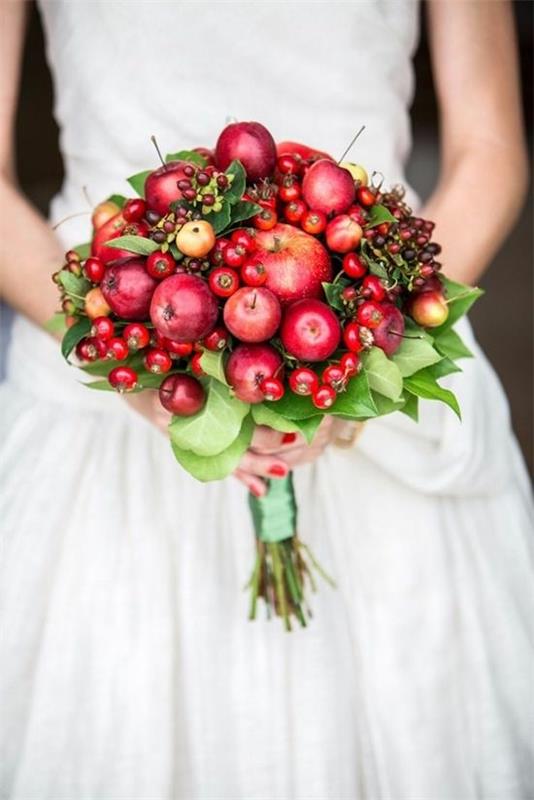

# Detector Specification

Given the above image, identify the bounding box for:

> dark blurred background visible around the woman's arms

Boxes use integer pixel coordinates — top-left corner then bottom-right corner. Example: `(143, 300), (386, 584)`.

(8, 0), (533, 467)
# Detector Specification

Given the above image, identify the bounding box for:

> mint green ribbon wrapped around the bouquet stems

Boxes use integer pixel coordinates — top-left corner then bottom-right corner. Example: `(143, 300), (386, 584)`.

(249, 472), (297, 542)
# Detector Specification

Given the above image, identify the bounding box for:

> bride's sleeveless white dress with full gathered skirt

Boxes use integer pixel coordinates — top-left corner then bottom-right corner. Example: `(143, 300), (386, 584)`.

(0, 0), (534, 800)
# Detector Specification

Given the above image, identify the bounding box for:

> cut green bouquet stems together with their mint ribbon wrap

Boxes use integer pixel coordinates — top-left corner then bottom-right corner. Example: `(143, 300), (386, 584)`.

(248, 473), (335, 631)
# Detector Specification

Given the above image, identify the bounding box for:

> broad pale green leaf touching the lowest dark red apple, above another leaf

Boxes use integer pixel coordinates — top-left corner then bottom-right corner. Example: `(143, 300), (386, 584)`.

(169, 378), (249, 456)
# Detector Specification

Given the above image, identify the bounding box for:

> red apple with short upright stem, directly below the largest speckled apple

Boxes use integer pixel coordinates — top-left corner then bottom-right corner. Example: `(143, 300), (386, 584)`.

(224, 286), (282, 342)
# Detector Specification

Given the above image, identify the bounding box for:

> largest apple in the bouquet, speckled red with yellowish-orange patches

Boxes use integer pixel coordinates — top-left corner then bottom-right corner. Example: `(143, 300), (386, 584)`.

(254, 224), (332, 305)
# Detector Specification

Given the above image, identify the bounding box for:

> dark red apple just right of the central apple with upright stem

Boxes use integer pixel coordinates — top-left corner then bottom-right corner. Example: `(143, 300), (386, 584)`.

(280, 300), (341, 361)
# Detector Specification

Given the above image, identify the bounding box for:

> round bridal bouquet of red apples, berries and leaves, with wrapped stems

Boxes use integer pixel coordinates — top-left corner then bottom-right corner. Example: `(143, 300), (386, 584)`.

(53, 122), (480, 629)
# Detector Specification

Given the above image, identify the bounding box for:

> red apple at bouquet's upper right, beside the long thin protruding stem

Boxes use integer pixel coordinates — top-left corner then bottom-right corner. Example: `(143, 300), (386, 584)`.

(302, 158), (355, 214)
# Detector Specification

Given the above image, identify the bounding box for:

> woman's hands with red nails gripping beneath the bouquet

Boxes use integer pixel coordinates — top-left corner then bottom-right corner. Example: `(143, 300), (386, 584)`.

(124, 390), (338, 497)
